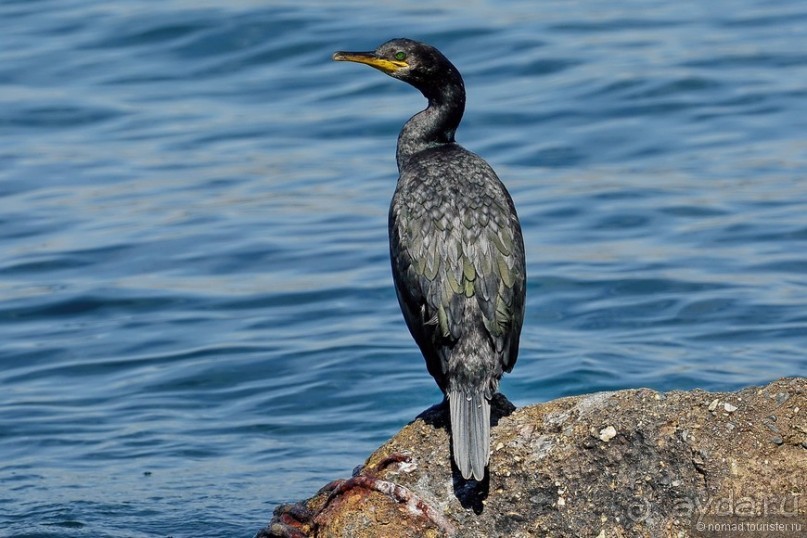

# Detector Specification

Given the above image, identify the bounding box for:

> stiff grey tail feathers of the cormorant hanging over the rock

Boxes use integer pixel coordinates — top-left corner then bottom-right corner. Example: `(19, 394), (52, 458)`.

(448, 390), (490, 480)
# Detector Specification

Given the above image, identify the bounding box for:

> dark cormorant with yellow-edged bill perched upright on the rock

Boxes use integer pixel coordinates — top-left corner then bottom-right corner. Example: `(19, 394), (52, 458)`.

(333, 38), (526, 481)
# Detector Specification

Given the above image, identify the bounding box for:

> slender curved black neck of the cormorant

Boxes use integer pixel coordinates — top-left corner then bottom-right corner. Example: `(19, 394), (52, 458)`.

(396, 73), (465, 172)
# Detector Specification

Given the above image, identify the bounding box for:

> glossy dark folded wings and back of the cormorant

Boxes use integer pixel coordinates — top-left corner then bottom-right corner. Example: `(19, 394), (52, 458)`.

(390, 149), (525, 383)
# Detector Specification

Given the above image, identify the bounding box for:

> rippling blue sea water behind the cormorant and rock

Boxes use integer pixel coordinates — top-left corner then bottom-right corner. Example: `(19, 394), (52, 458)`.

(0, 0), (807, 538)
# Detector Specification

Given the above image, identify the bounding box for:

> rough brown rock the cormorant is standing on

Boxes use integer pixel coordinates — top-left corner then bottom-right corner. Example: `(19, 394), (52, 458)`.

(258, 378), (807, 538)
